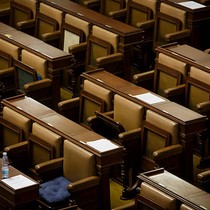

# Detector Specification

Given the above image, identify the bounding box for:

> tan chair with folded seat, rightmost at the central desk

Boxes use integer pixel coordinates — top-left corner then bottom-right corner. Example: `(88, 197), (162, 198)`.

(141, 110), (179, 171)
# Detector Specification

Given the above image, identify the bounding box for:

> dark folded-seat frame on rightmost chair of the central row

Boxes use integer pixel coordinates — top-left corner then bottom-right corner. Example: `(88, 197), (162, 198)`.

(141, 121), (171, 169)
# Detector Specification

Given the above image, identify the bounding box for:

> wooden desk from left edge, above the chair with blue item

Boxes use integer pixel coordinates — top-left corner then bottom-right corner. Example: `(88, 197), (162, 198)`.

(0, 23), (72, 107)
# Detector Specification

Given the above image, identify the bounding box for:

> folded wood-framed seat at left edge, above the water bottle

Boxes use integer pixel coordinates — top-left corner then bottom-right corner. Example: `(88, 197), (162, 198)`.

(0, 117), (23, 151)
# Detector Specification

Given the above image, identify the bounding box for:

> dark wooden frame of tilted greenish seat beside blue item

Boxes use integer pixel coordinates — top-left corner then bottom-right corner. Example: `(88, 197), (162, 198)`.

(13, 60), (37, 91)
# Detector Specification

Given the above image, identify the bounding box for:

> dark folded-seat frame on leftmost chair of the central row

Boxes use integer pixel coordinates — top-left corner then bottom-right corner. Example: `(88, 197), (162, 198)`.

(79, 90), (105, 123)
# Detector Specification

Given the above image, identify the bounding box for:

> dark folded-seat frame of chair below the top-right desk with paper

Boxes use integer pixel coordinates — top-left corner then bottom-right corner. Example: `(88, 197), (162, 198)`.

(154, 12), (182, 46)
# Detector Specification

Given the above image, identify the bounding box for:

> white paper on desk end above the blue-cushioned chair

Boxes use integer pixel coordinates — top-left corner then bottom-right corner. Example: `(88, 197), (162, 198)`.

(86, 139), (118, 152)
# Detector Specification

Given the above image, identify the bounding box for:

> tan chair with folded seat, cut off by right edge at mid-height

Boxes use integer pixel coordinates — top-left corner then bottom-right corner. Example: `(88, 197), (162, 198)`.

(185, 66), (210, 111)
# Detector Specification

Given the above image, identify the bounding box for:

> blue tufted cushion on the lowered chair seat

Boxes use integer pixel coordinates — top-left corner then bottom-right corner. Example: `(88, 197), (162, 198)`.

(39, 176), (70, 204)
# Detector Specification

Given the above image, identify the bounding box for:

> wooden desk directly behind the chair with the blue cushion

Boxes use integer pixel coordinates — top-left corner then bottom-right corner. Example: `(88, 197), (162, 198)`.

(2, 96), (123, 210)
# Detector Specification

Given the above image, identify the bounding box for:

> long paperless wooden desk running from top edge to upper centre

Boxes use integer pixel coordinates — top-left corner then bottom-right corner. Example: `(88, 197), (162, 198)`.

(39, 0), (142, 81)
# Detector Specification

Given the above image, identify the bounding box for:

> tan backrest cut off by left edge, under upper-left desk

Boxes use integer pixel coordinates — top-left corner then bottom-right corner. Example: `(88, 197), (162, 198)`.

(0, 39), (20, 60)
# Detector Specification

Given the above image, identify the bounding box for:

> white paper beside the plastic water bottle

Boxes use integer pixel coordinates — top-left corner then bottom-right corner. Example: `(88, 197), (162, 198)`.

(1, 174), (36, 190)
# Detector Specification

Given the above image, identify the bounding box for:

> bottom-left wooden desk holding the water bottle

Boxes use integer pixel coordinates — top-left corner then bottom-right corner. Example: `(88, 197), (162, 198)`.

(0, 159), (39, 210)
